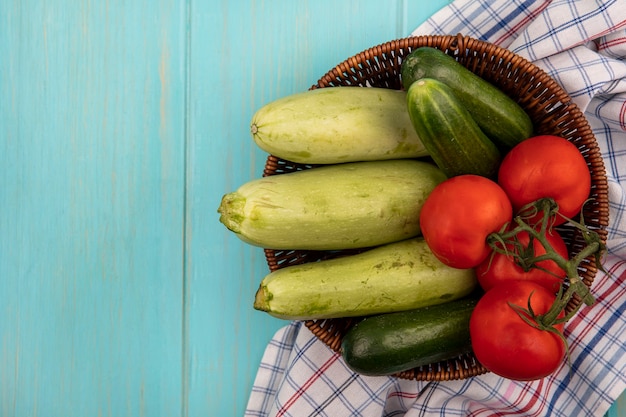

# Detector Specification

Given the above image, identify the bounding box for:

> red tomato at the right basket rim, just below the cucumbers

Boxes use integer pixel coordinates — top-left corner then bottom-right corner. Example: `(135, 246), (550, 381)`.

(498, 135), (591, 224)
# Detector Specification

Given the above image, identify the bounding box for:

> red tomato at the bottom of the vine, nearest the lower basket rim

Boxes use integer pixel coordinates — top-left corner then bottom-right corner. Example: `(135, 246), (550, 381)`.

(469, 281), (566, 381)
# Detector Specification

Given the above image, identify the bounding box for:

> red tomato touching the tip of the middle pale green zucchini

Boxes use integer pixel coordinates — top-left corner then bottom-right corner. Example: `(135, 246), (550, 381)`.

(420, 175), (513, 269)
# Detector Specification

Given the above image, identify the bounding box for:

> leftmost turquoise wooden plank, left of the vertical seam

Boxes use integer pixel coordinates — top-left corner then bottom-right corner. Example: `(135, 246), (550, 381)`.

(0, 1), (185, 416)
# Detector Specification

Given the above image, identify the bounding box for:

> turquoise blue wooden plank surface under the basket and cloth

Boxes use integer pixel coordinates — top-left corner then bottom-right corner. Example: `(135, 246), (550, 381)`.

(0, 0), (625, 417)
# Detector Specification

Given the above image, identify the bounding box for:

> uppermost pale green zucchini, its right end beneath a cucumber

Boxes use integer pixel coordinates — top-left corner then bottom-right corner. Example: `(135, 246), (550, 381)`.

(250, 87), (427, 164)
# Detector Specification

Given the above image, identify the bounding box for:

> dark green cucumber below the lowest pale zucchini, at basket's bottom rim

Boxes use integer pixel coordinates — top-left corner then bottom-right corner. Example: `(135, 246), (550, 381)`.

(341, 295), (478, 376)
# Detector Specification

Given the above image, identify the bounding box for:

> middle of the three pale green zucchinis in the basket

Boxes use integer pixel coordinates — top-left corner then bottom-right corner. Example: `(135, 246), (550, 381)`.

(218, 159), (446, 250)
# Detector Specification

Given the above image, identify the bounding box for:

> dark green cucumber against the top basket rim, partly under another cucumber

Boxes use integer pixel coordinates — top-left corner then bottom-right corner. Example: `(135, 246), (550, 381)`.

(400, 46), (533, 149)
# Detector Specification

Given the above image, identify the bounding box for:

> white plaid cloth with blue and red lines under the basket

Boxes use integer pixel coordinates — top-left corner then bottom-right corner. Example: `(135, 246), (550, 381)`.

(246, 0), (626, 417)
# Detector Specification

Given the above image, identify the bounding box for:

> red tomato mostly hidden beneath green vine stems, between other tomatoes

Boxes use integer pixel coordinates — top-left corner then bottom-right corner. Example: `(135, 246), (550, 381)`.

(476, 230), (569, 293)
